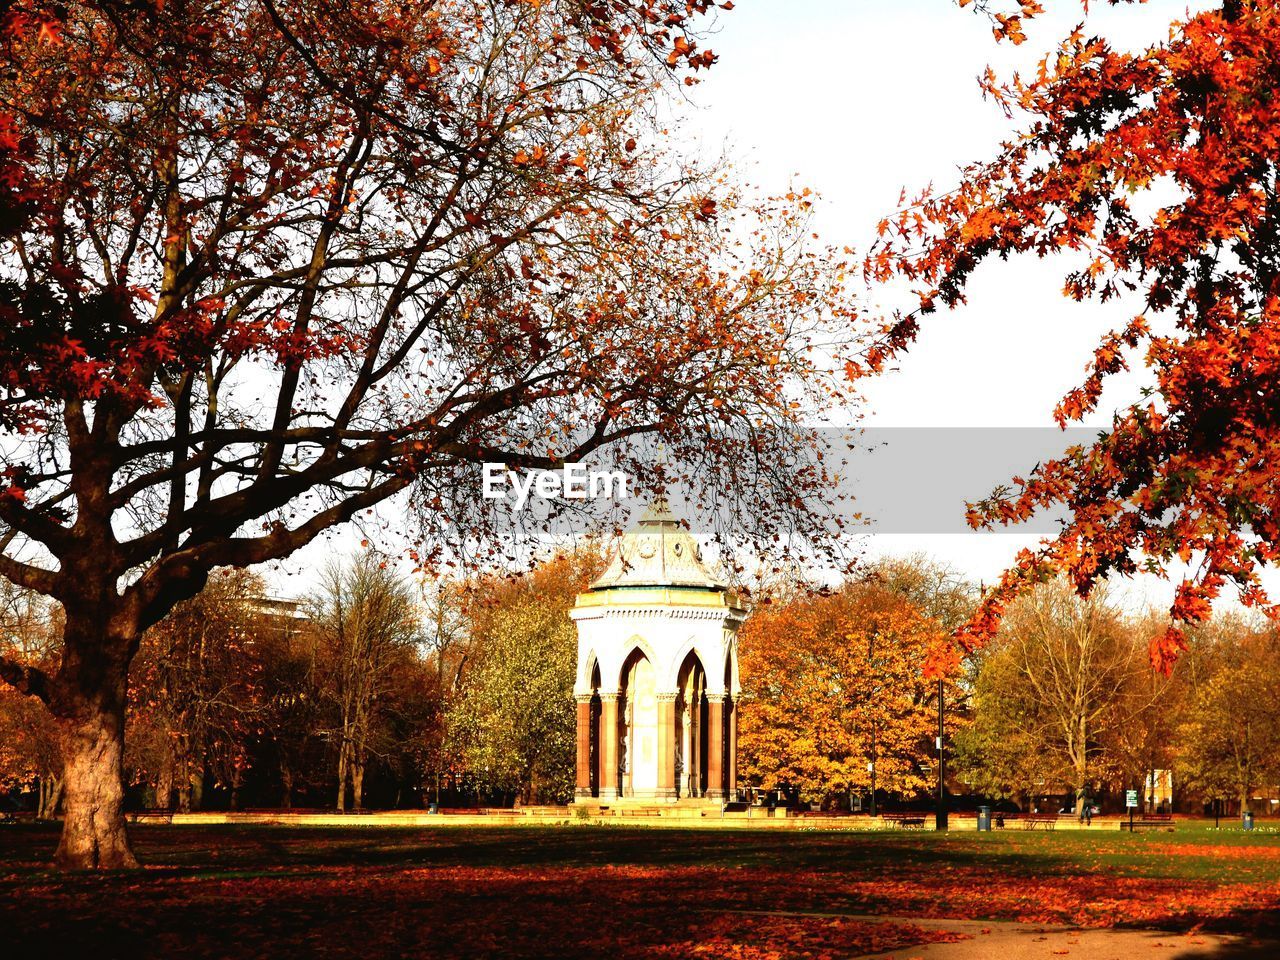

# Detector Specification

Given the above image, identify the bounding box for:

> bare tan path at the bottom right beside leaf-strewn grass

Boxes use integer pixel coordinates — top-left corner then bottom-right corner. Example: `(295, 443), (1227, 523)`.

(839, 916), (1280, 960)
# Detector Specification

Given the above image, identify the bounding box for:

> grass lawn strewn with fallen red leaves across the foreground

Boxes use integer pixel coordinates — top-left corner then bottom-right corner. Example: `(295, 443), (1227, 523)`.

(0, 823), (1280, 959)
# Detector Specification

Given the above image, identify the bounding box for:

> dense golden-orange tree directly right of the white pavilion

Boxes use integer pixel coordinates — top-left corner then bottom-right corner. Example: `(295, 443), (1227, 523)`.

(739, 576), (955, 803)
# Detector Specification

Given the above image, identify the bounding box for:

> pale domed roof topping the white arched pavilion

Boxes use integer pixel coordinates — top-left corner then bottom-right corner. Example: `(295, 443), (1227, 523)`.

(591, 500), (726, 590)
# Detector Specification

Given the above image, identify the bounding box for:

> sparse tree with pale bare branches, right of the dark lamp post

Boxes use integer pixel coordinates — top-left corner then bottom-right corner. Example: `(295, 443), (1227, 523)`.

(959, 581), (1158, 796)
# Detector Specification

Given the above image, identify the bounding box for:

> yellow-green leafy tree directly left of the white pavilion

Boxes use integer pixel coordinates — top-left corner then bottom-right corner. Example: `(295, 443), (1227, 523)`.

(445, 550), (602, 804)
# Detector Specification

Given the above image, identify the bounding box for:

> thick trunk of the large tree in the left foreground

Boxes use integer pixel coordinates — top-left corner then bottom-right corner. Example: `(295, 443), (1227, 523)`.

(50, 609), (138, 870)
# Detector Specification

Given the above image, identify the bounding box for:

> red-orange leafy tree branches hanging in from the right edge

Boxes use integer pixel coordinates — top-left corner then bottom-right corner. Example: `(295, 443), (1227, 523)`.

(856, 0), (1280, 668)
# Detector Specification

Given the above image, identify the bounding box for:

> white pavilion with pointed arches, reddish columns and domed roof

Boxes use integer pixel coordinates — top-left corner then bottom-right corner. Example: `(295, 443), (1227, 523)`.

(570, 504), (746, 803)
